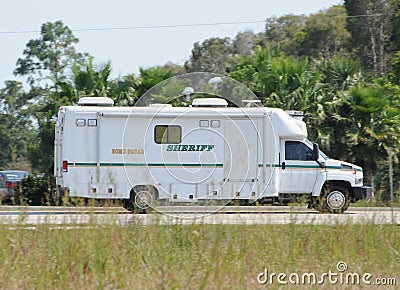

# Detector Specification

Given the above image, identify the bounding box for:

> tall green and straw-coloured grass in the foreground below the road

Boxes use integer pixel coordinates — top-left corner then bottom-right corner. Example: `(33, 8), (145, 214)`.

(0, 222), (400, 289)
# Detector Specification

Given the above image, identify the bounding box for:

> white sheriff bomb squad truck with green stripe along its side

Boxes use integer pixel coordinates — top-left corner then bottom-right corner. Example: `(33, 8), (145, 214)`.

(55, 97), (366, 213)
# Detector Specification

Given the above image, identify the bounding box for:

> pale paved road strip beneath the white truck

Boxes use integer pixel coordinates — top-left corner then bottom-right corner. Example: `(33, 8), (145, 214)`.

(0, 206), (400, 226)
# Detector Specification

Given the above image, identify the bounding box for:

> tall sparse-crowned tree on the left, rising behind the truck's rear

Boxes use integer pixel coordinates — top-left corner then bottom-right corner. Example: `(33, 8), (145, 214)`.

(14, 21), (88, 174)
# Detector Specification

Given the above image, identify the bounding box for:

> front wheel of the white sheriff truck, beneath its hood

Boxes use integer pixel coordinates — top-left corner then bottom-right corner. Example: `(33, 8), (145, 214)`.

(312, 185), (350, 213)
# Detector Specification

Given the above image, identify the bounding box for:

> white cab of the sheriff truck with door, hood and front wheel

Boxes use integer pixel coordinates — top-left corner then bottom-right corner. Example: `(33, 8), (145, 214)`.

(280, 139), (367, 213)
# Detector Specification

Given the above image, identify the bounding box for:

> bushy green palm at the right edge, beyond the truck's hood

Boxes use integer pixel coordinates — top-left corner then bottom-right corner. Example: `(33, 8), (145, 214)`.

(333, 84), (400, 181)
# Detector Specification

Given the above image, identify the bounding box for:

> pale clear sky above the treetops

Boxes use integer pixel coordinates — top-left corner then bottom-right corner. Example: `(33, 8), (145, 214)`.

(0, 0), (343, 87)
